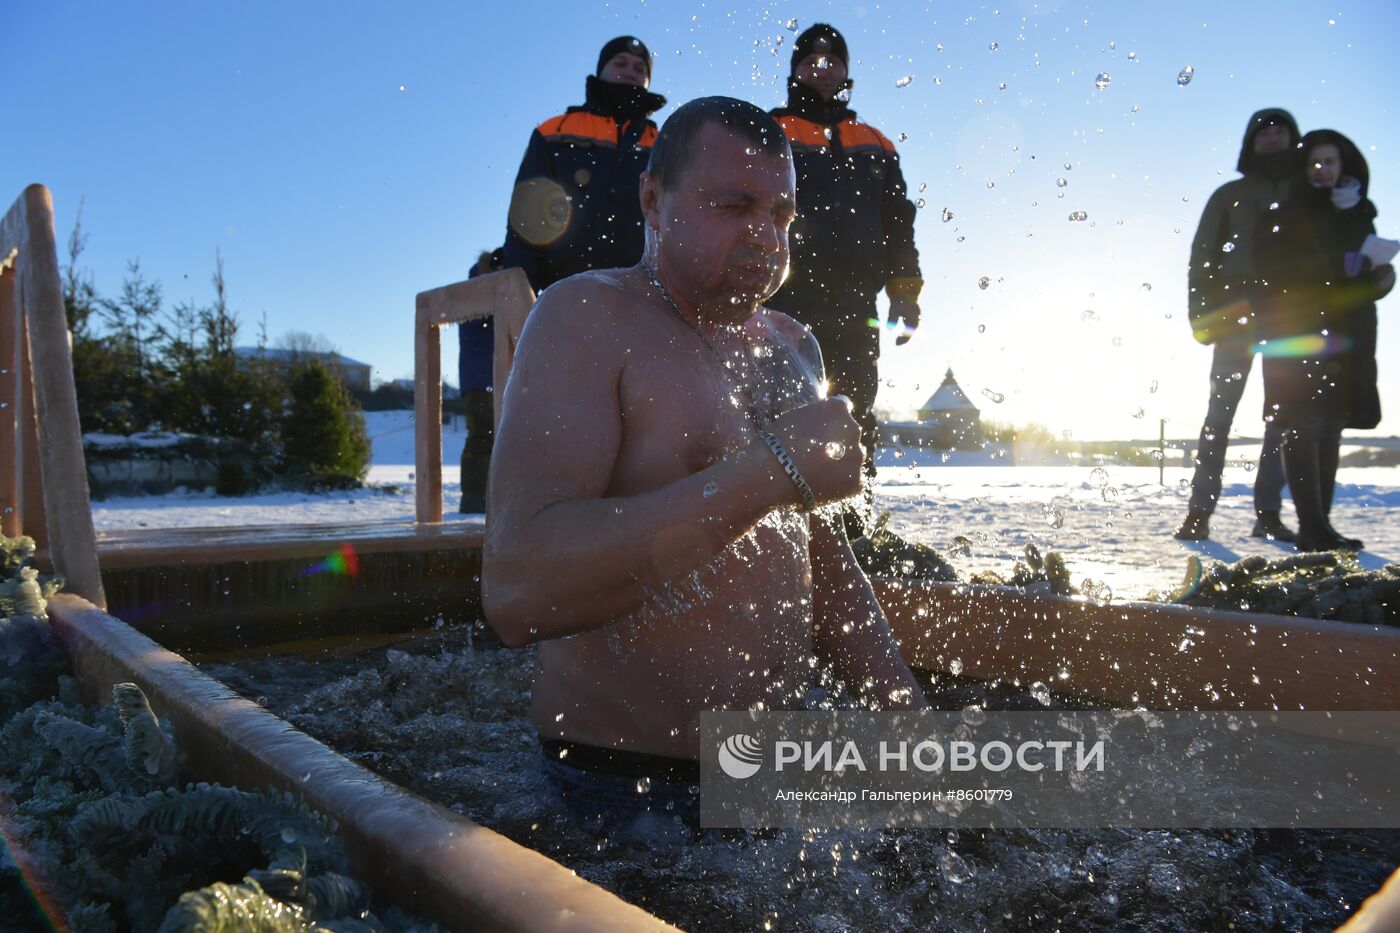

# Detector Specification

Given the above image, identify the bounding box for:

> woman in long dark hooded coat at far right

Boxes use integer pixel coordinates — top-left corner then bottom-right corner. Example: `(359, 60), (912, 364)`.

(1254, 130), (1394, 551)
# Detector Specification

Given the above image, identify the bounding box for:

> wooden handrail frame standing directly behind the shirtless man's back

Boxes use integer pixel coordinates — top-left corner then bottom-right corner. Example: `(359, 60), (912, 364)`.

(413, 269), (535, 523)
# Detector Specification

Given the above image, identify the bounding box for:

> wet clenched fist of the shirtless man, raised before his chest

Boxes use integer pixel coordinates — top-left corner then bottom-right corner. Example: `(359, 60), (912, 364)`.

(753, 395), (865, 503)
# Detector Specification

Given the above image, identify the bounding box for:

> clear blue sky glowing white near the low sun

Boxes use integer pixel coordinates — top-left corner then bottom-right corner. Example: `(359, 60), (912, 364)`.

(10, 0), (1400, 437)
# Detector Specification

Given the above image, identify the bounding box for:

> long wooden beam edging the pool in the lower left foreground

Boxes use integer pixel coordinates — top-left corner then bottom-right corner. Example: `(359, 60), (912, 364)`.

(49, 595), (675, 933)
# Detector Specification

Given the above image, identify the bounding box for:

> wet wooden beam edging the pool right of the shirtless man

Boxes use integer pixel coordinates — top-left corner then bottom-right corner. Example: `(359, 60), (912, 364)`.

(875, 580), (1400, 710)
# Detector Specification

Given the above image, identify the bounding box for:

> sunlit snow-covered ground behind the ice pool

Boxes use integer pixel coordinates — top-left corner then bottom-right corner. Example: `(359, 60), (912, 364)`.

(92, 412), (1400, 598)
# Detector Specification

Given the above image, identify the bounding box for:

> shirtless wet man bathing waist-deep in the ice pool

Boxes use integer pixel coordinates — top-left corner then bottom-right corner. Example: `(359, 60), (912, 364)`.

(482, 98), (925, 761)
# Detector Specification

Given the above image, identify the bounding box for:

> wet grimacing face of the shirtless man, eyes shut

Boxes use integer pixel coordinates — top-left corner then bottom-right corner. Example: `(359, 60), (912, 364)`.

(641, 123), (797, 314)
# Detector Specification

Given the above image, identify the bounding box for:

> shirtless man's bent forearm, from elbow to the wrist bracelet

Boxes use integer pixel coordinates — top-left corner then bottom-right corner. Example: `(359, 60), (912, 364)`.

(483, 447), (790, 644)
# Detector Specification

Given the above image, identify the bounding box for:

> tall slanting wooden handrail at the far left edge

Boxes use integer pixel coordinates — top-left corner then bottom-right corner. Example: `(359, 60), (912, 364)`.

(0, 185), (106, 605)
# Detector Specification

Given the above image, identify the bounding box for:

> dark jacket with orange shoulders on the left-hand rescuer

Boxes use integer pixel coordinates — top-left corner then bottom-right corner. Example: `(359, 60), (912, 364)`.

(503, 76), (666, 291)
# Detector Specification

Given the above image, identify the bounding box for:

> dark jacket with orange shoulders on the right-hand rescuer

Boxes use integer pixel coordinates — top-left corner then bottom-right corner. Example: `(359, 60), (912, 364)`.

(773, 83), (921, 303)
